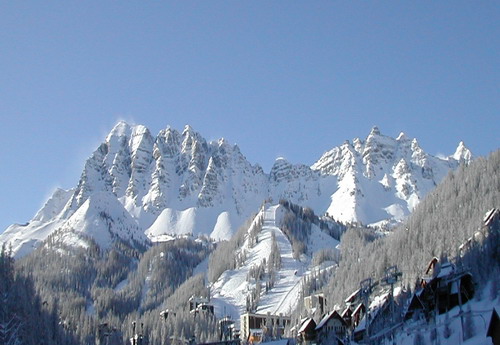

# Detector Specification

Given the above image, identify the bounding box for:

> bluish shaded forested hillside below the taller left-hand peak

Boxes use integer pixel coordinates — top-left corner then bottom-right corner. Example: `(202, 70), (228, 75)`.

(13, 238), (212, 344)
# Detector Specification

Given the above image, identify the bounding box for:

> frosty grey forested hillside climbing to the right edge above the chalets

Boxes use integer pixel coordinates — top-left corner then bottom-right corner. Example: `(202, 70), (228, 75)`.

(326, 150), (500, 305)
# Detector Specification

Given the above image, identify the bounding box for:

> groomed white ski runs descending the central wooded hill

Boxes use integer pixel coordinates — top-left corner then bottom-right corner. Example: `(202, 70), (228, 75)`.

(211, 205), (339, 320)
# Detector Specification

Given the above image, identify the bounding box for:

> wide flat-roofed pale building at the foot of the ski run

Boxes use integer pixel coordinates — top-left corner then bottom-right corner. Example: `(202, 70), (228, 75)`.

(240, 313), (290, 343)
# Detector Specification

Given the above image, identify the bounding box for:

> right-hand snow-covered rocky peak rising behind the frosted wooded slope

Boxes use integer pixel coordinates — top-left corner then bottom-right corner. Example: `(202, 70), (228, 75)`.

(311, 127), (472, 224)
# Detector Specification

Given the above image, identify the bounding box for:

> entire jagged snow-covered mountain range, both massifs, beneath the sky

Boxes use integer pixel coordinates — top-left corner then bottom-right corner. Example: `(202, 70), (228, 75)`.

(0, 122), (472, 256)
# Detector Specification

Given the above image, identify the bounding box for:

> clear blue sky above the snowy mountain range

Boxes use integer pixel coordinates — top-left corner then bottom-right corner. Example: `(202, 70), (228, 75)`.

(0, 1), (500, 231)
